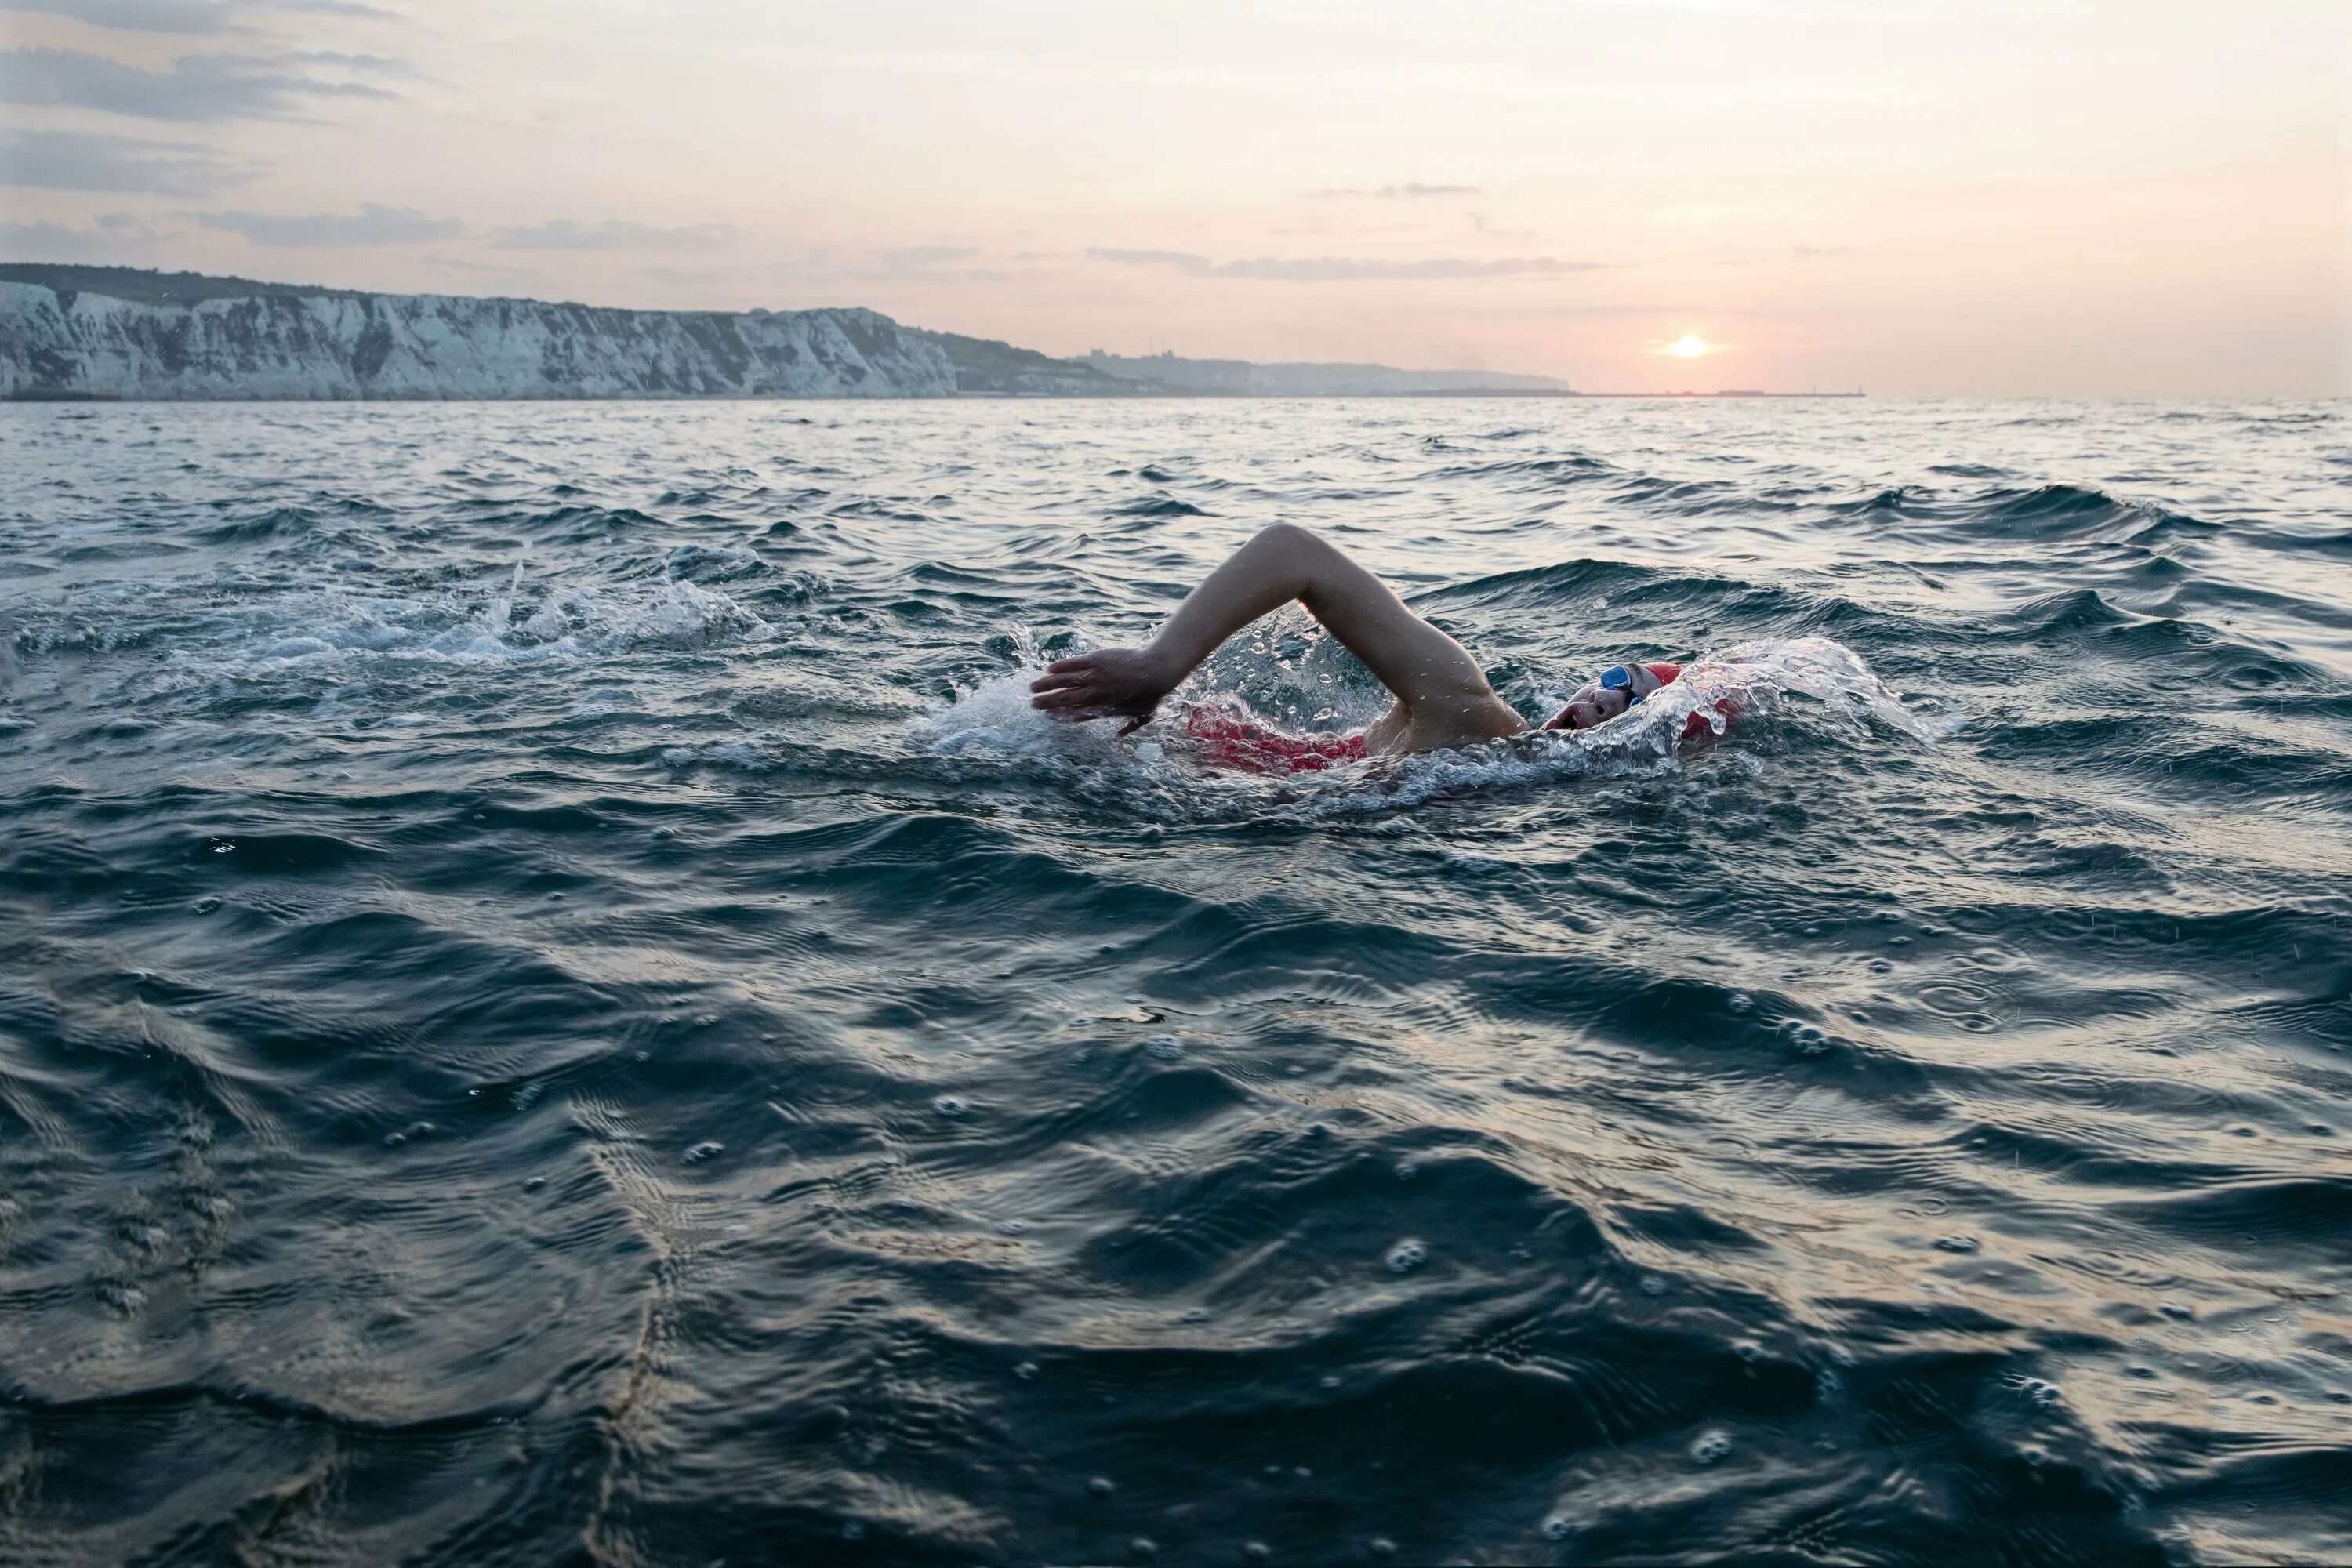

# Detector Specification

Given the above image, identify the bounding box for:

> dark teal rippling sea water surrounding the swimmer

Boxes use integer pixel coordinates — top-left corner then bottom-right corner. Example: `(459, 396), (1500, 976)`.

(0, 400), (2352, 1568)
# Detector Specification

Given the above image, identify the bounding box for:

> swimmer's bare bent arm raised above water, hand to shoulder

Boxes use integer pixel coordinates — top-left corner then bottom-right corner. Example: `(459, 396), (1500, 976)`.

(1030, 522), (1526, 750)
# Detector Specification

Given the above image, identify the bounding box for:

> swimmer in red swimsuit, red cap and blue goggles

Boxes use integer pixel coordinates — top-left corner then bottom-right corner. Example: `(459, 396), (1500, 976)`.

(1030, 522), (1705, 771)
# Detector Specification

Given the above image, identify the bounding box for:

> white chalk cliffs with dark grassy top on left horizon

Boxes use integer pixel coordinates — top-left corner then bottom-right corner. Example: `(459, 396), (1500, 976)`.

(0, 266), (1138, 400)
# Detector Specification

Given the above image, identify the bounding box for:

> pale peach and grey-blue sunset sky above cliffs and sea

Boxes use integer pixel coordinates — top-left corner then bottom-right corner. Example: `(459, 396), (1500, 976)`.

(0, 0), (2352, 397)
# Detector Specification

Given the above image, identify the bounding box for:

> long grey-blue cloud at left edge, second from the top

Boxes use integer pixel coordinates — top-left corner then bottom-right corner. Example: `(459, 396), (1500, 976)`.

(0, 49), (397, 120)
